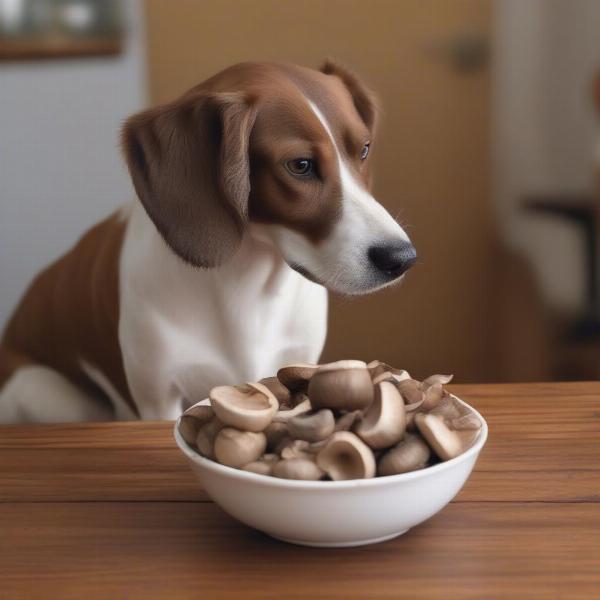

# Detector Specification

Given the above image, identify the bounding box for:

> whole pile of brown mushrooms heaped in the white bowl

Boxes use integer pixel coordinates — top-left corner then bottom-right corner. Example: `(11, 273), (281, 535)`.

(179, 360), (481, 481)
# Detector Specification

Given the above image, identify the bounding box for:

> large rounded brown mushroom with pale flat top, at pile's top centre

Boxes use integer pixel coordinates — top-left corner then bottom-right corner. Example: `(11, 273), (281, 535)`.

(308, 360), (373, 411)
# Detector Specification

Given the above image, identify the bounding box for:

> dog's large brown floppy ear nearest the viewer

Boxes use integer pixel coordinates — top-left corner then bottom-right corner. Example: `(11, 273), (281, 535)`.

(122, 90), (256, 267)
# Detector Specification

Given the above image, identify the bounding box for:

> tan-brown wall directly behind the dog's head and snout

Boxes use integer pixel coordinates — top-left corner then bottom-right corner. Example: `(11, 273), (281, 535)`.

(147, 0), (496, 380)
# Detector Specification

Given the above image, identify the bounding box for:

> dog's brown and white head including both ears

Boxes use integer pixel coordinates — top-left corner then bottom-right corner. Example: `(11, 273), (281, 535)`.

(123, 62), (416, 294)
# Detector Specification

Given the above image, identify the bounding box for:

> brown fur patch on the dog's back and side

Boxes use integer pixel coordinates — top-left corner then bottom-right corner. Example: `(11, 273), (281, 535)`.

(0, 210), (132, 412)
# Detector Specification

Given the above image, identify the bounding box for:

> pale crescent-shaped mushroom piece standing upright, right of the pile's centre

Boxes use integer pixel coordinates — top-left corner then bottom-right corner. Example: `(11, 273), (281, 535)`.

(354, 381), (406, 449)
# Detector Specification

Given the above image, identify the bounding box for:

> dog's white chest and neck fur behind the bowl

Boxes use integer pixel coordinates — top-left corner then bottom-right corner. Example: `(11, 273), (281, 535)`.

(119, 207), (327, 418)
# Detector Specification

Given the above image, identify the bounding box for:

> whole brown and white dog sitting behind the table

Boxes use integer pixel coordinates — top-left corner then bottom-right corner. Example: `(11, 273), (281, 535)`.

(0, 63), (416, 422)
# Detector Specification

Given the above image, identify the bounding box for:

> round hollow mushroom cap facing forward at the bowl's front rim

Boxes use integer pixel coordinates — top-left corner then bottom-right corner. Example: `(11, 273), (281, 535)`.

(317, 431), (375, 481)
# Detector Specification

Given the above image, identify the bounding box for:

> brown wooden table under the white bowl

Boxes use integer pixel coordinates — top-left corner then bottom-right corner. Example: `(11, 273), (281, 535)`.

(0, 383), (600, 600)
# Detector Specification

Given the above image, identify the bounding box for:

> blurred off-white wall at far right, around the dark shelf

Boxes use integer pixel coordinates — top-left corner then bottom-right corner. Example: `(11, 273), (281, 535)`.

(493, 0), (600, 309)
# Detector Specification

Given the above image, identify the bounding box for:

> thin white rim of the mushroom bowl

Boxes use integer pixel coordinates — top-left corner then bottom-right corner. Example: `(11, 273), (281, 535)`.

(173, 394), (488, 491)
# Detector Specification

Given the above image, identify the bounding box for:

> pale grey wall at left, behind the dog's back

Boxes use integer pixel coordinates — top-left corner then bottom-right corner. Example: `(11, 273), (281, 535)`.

(0, 0), (146, 329)
